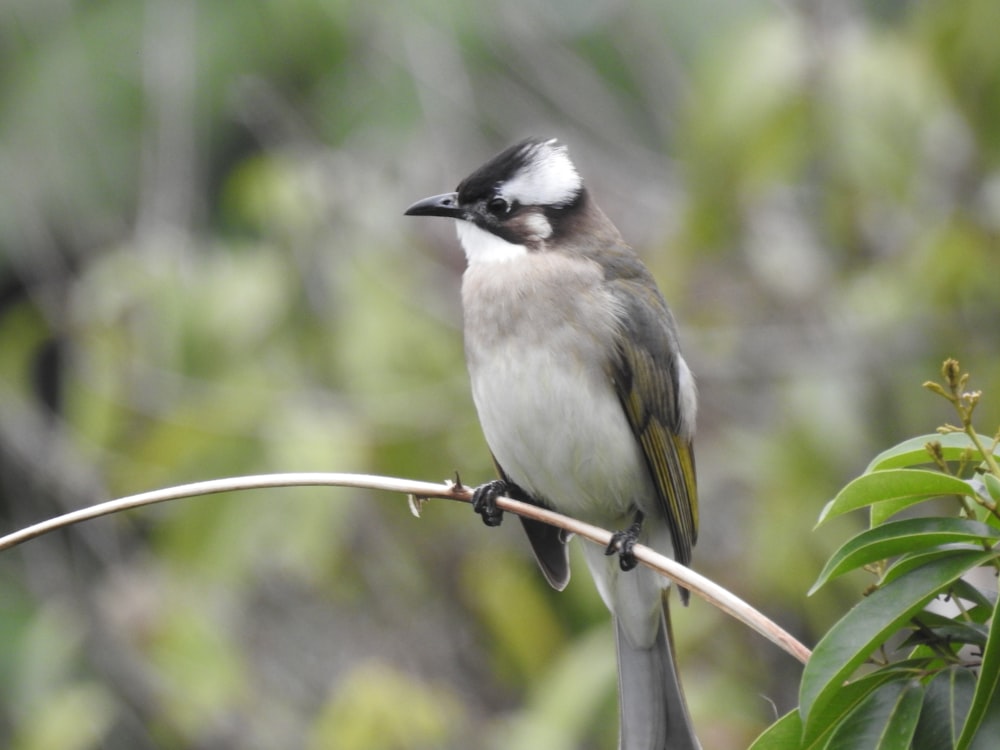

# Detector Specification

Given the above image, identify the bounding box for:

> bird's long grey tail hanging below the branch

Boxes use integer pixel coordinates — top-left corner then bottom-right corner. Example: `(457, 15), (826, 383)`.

(615, 599), (701, 750)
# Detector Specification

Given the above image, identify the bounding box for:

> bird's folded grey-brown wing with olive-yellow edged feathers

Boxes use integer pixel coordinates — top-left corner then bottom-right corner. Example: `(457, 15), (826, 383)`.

(610, 278), (698, 565)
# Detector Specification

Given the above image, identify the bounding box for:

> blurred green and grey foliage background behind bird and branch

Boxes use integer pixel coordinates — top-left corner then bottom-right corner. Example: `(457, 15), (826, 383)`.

(0, 0), (1000, 750)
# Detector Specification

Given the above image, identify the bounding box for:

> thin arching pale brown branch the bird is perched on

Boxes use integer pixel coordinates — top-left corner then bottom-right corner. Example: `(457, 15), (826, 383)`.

(0, 472), (810, 664)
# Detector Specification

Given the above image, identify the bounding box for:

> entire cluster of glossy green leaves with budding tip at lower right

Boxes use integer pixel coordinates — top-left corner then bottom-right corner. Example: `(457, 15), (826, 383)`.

(753, 360), (1000, 750)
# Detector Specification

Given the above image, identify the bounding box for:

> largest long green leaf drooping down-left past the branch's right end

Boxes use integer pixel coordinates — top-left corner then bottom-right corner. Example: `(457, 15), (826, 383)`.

(799, 552), (992, 730)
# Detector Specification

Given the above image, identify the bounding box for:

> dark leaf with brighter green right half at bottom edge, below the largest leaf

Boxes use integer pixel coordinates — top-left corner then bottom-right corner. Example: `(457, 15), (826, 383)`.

(828, 680), (924, 750)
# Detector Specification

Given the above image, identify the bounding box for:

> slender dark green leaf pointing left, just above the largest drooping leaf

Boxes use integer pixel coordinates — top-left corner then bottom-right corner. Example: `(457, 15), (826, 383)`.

(809, 517), (1000, 595)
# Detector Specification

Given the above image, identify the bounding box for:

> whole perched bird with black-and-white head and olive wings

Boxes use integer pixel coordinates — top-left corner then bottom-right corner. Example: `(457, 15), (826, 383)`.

(405, 138), (700, 750)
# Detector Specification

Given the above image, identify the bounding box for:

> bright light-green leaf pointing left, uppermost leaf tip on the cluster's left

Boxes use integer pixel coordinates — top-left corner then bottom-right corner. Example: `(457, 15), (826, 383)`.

(817, 469), (975, 525)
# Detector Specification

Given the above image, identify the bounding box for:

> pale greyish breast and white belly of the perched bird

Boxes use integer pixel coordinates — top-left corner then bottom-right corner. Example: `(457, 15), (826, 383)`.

(463, 256), (654, 527)
